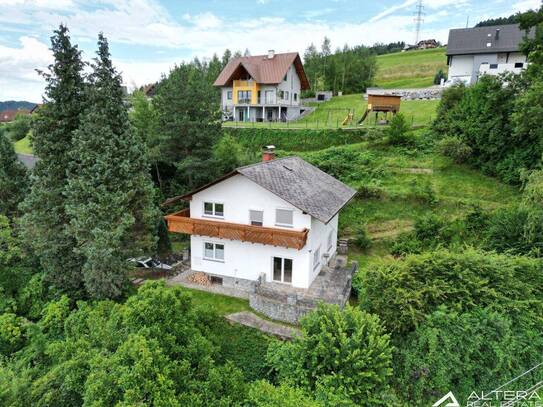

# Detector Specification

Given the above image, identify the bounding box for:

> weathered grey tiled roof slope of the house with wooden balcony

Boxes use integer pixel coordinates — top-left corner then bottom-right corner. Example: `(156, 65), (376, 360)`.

(236, 157), (356, 223)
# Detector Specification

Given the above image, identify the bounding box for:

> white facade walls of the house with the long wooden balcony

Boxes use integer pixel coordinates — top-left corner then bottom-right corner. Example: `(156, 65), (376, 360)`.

(190, 175), (338, 288)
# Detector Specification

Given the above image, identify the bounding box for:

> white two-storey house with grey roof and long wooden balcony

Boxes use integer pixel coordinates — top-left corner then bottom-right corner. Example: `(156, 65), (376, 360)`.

(166, 150), (356, 291)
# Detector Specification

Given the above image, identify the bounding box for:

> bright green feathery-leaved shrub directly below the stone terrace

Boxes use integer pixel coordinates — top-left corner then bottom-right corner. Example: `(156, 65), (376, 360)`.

(267, 304), (392, 406)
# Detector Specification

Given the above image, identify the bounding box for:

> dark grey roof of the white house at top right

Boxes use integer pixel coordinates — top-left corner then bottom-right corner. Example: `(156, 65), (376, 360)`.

(447, 24), (532, 55)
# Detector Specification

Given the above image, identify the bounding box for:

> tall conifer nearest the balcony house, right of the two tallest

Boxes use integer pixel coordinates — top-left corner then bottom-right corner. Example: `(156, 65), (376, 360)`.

(66, 34), (158, 298)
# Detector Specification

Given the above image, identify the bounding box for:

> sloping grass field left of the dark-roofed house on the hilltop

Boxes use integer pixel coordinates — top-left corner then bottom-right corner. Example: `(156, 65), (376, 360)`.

(375, 48), (447, 89)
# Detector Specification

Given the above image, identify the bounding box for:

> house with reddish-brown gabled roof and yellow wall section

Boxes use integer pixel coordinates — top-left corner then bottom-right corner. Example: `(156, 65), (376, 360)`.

(214, 50), (309, 122)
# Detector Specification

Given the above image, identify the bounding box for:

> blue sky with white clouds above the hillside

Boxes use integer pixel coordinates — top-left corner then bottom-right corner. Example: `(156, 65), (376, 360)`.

(0, 0), (541, 102)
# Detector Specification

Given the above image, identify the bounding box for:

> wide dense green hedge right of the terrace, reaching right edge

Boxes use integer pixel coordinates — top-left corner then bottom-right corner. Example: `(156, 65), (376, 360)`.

(361, 249), (543, 334)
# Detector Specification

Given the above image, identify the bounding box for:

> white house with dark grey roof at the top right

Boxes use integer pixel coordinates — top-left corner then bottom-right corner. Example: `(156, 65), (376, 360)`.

(447, 24), (533, 85)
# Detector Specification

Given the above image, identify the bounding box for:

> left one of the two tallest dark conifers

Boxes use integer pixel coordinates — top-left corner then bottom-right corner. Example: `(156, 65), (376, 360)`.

(23, 25), (86, 293)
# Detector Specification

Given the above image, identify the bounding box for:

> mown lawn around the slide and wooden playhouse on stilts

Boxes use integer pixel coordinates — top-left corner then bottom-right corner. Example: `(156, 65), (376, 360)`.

(223, 94), (439, 129)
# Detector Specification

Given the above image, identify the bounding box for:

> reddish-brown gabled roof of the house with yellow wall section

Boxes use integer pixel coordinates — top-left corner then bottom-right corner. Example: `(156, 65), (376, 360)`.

(213, 52), (310, 90)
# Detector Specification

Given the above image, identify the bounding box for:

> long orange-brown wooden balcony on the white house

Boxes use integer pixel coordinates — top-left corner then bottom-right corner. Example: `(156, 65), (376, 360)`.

(164, 209), (309, 250)
